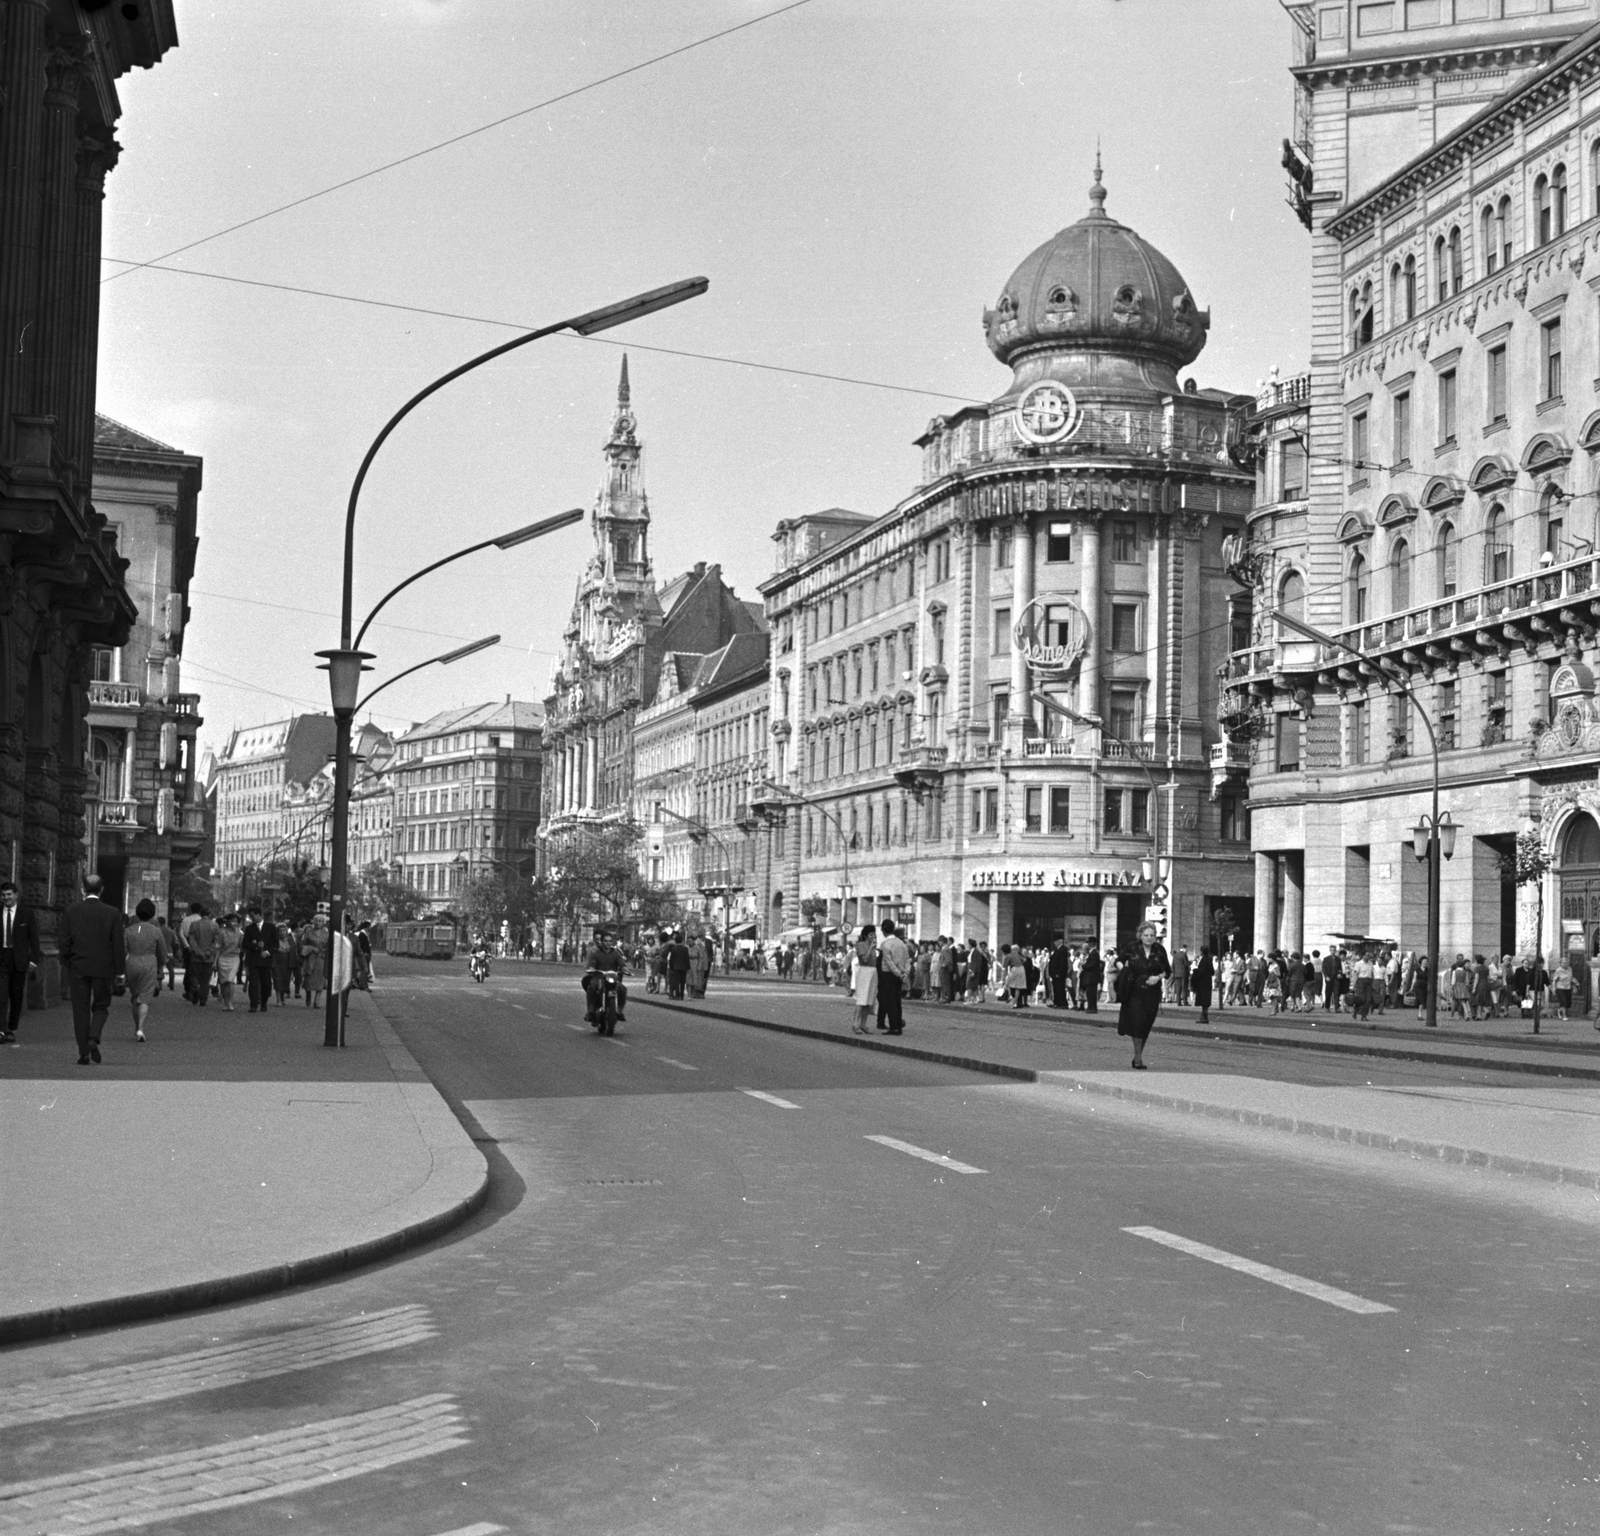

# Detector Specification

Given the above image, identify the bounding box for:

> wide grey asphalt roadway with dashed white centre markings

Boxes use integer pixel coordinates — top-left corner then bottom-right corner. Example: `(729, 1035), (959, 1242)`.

(0, 962), (1600, 1536)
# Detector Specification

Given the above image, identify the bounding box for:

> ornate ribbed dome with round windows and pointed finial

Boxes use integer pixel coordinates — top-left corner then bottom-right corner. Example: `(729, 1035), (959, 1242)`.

(984, 155), (1211, 371)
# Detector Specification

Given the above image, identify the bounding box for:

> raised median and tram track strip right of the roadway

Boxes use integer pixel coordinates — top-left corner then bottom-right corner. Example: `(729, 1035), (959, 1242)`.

(629, 971), (1600, 1189)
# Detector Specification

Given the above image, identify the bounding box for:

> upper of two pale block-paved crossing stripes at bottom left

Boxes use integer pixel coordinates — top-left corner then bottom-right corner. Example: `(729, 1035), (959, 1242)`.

(0, 1304), (438, 1427)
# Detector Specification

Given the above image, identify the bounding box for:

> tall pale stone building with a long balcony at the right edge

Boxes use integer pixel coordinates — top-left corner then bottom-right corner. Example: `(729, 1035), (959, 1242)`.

(1222, 0), (1600, 1002)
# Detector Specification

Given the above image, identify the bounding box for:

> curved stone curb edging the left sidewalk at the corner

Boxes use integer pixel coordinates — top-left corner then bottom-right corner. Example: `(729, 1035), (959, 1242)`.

(0, 994), (490, 1347)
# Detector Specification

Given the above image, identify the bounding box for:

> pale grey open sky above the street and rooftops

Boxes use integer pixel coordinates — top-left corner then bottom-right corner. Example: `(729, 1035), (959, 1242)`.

(98, 0), (1309, 749)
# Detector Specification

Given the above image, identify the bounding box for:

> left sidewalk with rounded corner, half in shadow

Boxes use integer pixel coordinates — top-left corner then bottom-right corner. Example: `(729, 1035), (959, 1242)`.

(0, 992), (488, 1344)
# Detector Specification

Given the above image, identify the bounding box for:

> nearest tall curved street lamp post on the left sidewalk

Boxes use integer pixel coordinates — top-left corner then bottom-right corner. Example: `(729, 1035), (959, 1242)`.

(317, 277), (710, 1046)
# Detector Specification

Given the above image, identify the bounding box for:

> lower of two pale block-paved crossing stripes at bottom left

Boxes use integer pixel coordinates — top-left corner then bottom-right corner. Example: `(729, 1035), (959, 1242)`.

(0, 1392), (470, 1536)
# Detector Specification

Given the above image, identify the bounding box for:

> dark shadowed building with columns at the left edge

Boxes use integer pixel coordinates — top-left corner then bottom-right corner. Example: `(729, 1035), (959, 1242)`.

(0, 0), (178, 998)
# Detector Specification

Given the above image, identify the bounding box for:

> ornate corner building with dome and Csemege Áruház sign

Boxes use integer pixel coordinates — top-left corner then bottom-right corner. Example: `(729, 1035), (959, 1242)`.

(752, 165), (1254, 954)
